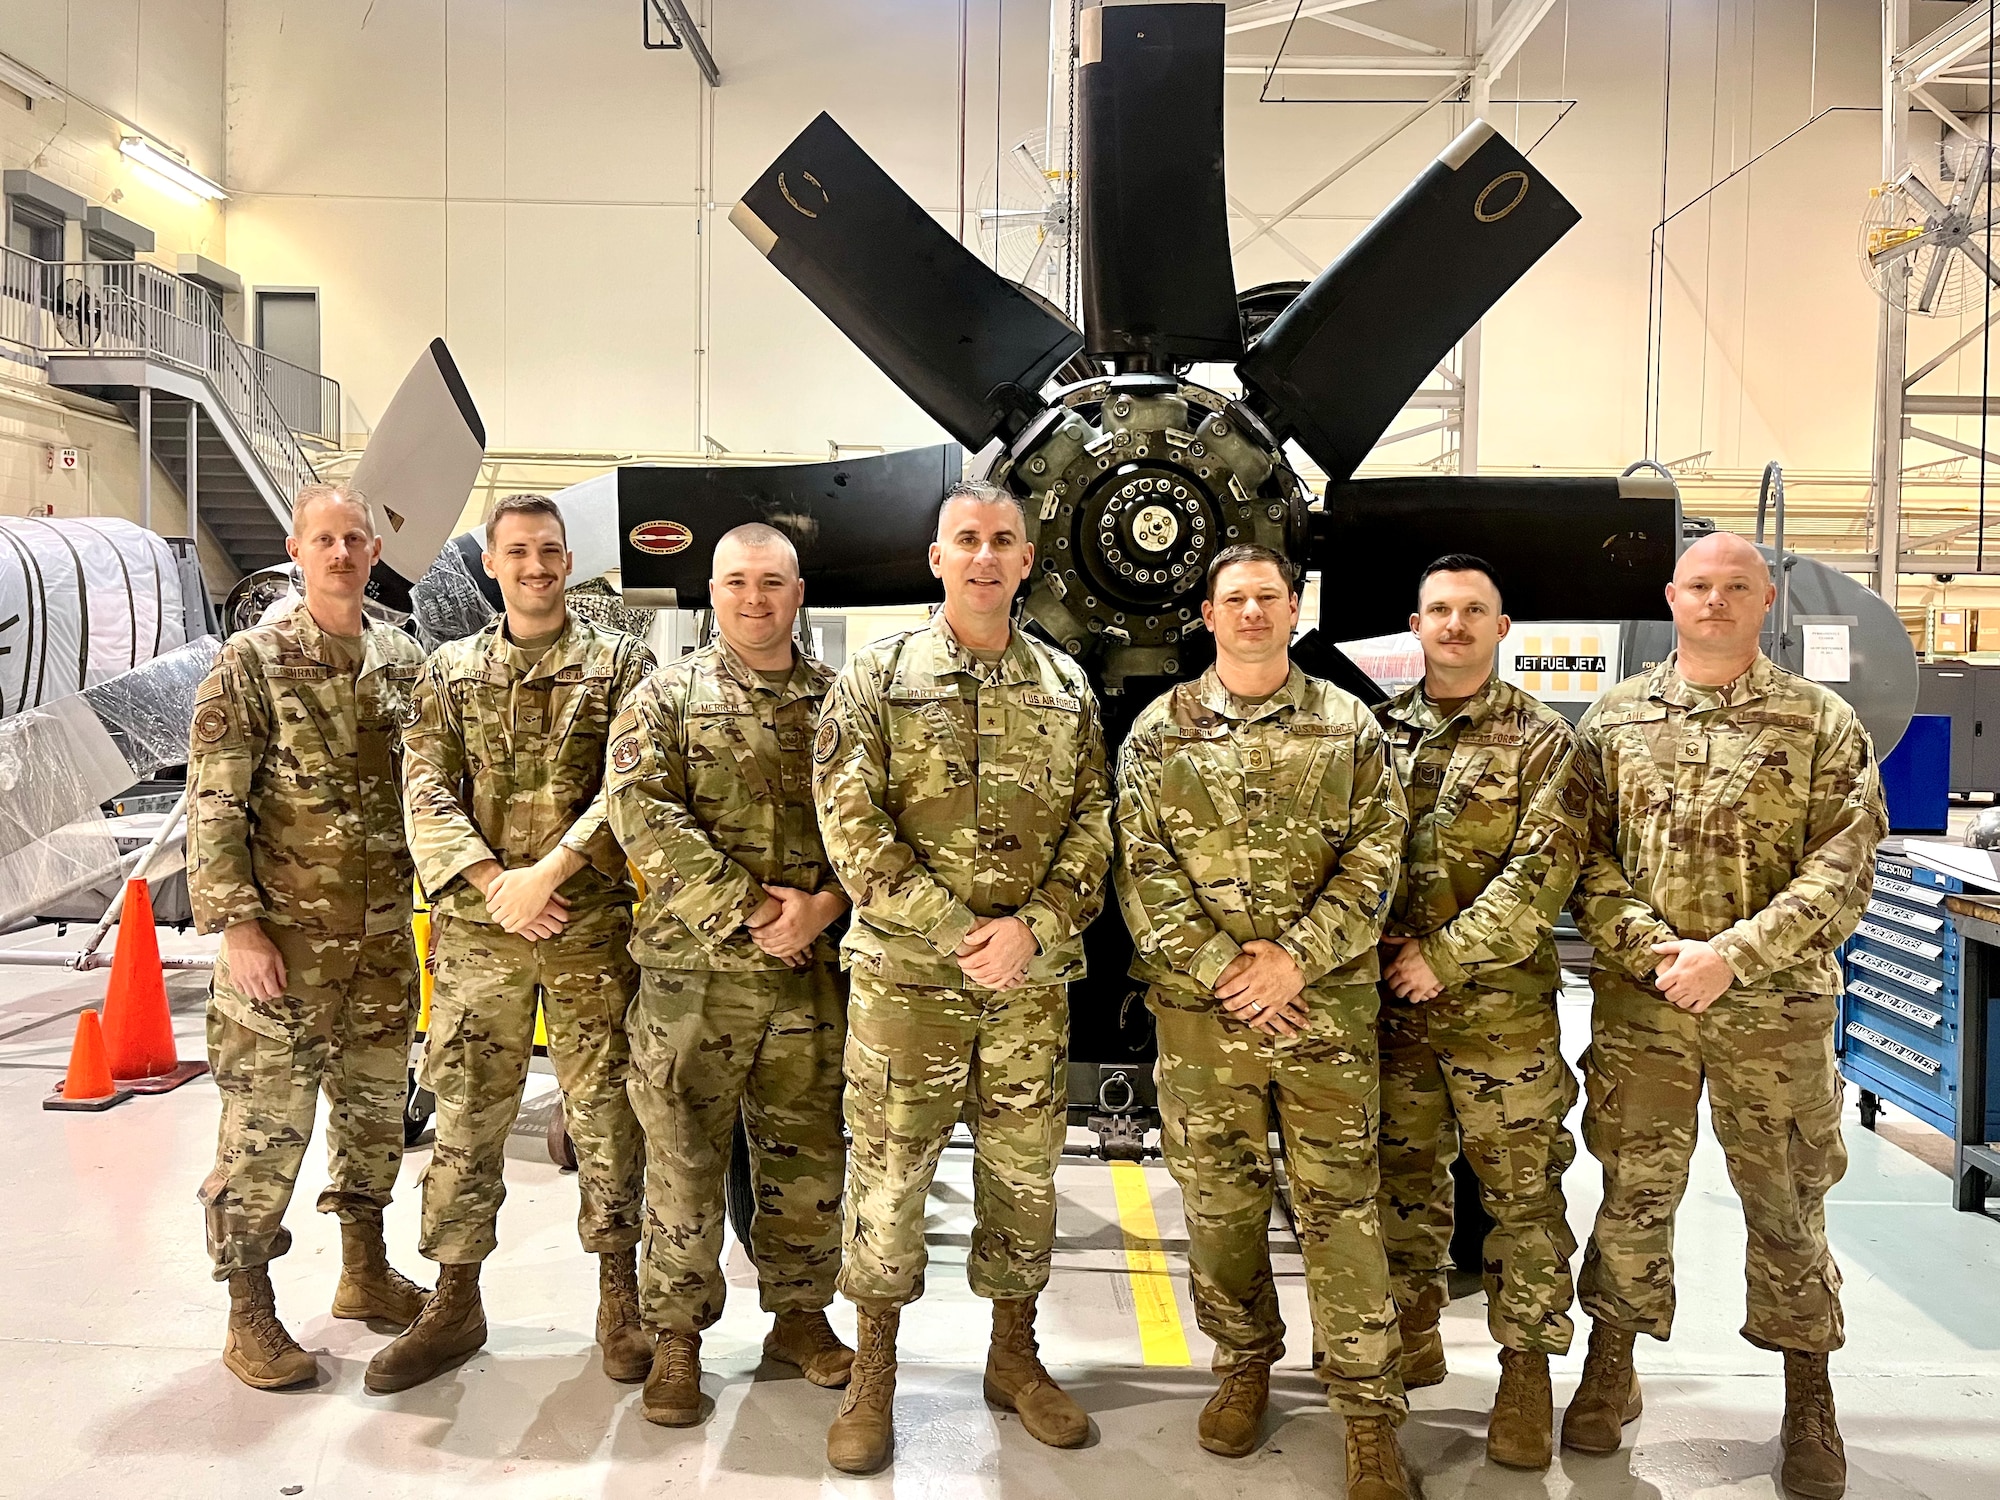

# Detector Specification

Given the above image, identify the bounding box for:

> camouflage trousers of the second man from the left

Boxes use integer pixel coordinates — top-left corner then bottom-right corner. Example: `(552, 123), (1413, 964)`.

(418, 906), (644, 1266)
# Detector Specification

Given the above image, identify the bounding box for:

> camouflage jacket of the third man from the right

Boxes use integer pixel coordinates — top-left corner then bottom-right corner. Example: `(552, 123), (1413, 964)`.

(1118, 666), (1410, 1004)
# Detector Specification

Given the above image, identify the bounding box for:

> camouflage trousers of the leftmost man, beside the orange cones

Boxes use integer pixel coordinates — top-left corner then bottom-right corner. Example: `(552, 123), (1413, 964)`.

(198, 924), (416, 1282)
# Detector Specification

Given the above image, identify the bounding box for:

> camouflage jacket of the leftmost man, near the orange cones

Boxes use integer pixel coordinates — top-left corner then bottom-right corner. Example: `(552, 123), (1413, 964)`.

(188, 604), (424, 938)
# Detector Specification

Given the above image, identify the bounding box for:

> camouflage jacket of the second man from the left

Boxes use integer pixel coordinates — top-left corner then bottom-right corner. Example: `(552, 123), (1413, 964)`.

(404, 612), (652, 922)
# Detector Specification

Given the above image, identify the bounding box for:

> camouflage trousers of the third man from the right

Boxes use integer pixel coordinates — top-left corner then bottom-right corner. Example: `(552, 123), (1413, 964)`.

(1146, 984), (1408, 1420)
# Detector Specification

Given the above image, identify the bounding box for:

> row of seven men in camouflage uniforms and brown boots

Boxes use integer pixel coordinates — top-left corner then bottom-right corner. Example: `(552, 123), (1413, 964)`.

(190, 486), (1886, 1500)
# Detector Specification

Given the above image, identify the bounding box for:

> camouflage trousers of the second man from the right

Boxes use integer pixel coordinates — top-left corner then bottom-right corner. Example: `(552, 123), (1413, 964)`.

(1380, 986), (1576, 1354)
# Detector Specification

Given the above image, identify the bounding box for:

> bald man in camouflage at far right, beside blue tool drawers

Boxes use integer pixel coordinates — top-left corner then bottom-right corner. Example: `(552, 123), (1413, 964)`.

(1562, 532), (1888, 1500)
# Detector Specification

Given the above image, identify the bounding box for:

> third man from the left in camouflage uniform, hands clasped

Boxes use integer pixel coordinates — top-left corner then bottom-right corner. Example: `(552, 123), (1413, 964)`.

(606, 524), (854, 1426)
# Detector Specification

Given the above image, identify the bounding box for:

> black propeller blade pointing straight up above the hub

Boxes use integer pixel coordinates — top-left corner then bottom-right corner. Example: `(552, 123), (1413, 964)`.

(1076, 0), (1242, 370)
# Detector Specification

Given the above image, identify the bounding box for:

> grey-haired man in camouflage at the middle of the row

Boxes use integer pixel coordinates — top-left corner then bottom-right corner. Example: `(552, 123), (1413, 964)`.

(812, 484), (1112, 1474)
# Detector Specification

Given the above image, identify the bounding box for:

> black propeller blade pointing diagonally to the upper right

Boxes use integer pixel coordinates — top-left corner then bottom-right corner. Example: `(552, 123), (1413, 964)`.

(1236, 120), (1578, 480)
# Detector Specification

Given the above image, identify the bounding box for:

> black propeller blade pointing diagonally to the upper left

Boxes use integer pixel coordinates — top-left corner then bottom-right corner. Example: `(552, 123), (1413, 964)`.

(732, 114), (1084, 450)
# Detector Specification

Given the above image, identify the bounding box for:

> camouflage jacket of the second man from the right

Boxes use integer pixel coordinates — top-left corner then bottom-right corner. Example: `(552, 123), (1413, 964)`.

(1376, 676), (1590, 992)
